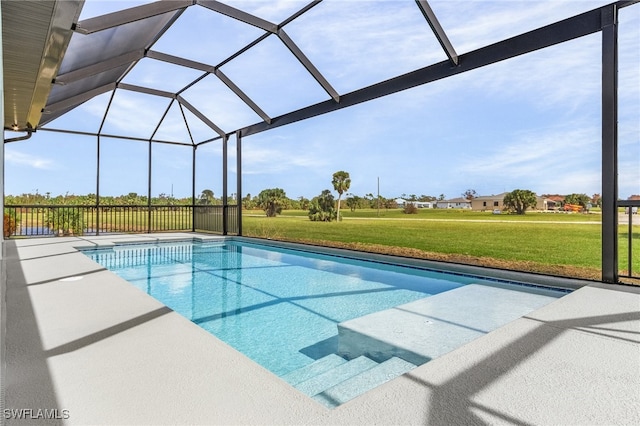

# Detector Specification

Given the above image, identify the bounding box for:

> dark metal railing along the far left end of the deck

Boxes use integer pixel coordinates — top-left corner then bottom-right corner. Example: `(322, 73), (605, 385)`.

(4, 205), (238, 238)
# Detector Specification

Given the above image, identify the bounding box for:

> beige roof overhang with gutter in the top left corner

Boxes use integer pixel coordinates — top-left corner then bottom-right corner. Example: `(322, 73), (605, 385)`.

(2, 0), (84, 131)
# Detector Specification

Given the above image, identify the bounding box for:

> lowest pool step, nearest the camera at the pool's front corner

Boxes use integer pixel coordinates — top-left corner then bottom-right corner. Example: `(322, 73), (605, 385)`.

(313, 357), (416, 408)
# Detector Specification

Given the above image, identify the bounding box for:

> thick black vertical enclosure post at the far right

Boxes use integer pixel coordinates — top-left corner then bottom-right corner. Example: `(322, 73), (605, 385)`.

(601, 4), (618, 283)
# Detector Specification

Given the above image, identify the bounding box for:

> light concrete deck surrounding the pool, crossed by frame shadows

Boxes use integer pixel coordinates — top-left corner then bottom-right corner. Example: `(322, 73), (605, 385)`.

(1, 233), (640, 425)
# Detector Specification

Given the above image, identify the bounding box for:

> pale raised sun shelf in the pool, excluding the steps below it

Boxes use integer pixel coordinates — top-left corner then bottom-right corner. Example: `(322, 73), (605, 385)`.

(338, 284), (557, 365)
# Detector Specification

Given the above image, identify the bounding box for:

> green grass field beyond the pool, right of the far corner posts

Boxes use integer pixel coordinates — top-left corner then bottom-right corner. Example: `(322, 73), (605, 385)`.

(243, 209), (640, 279)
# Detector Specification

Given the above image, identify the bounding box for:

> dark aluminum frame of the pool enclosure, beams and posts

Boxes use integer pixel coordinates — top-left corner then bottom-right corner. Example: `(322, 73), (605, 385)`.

(5, 0), (640, 283)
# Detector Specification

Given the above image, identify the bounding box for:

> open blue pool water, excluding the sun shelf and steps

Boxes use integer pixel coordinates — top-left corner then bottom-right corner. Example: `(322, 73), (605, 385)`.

(85, 241), (564, 406)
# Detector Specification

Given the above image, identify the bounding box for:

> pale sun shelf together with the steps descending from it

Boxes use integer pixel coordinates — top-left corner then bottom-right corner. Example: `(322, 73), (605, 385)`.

(282, 284), (557, 408)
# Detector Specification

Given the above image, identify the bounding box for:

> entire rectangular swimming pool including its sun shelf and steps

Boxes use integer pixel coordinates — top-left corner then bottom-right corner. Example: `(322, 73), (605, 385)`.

(84, 240), (566, 407)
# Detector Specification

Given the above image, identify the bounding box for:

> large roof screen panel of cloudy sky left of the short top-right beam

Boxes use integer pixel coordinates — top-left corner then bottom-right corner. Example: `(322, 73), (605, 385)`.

(286, 1), (446, 93)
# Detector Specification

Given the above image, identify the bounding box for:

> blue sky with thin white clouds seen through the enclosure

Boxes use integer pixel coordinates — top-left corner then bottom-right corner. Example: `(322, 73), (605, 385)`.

(5, 0), (640, 198)
